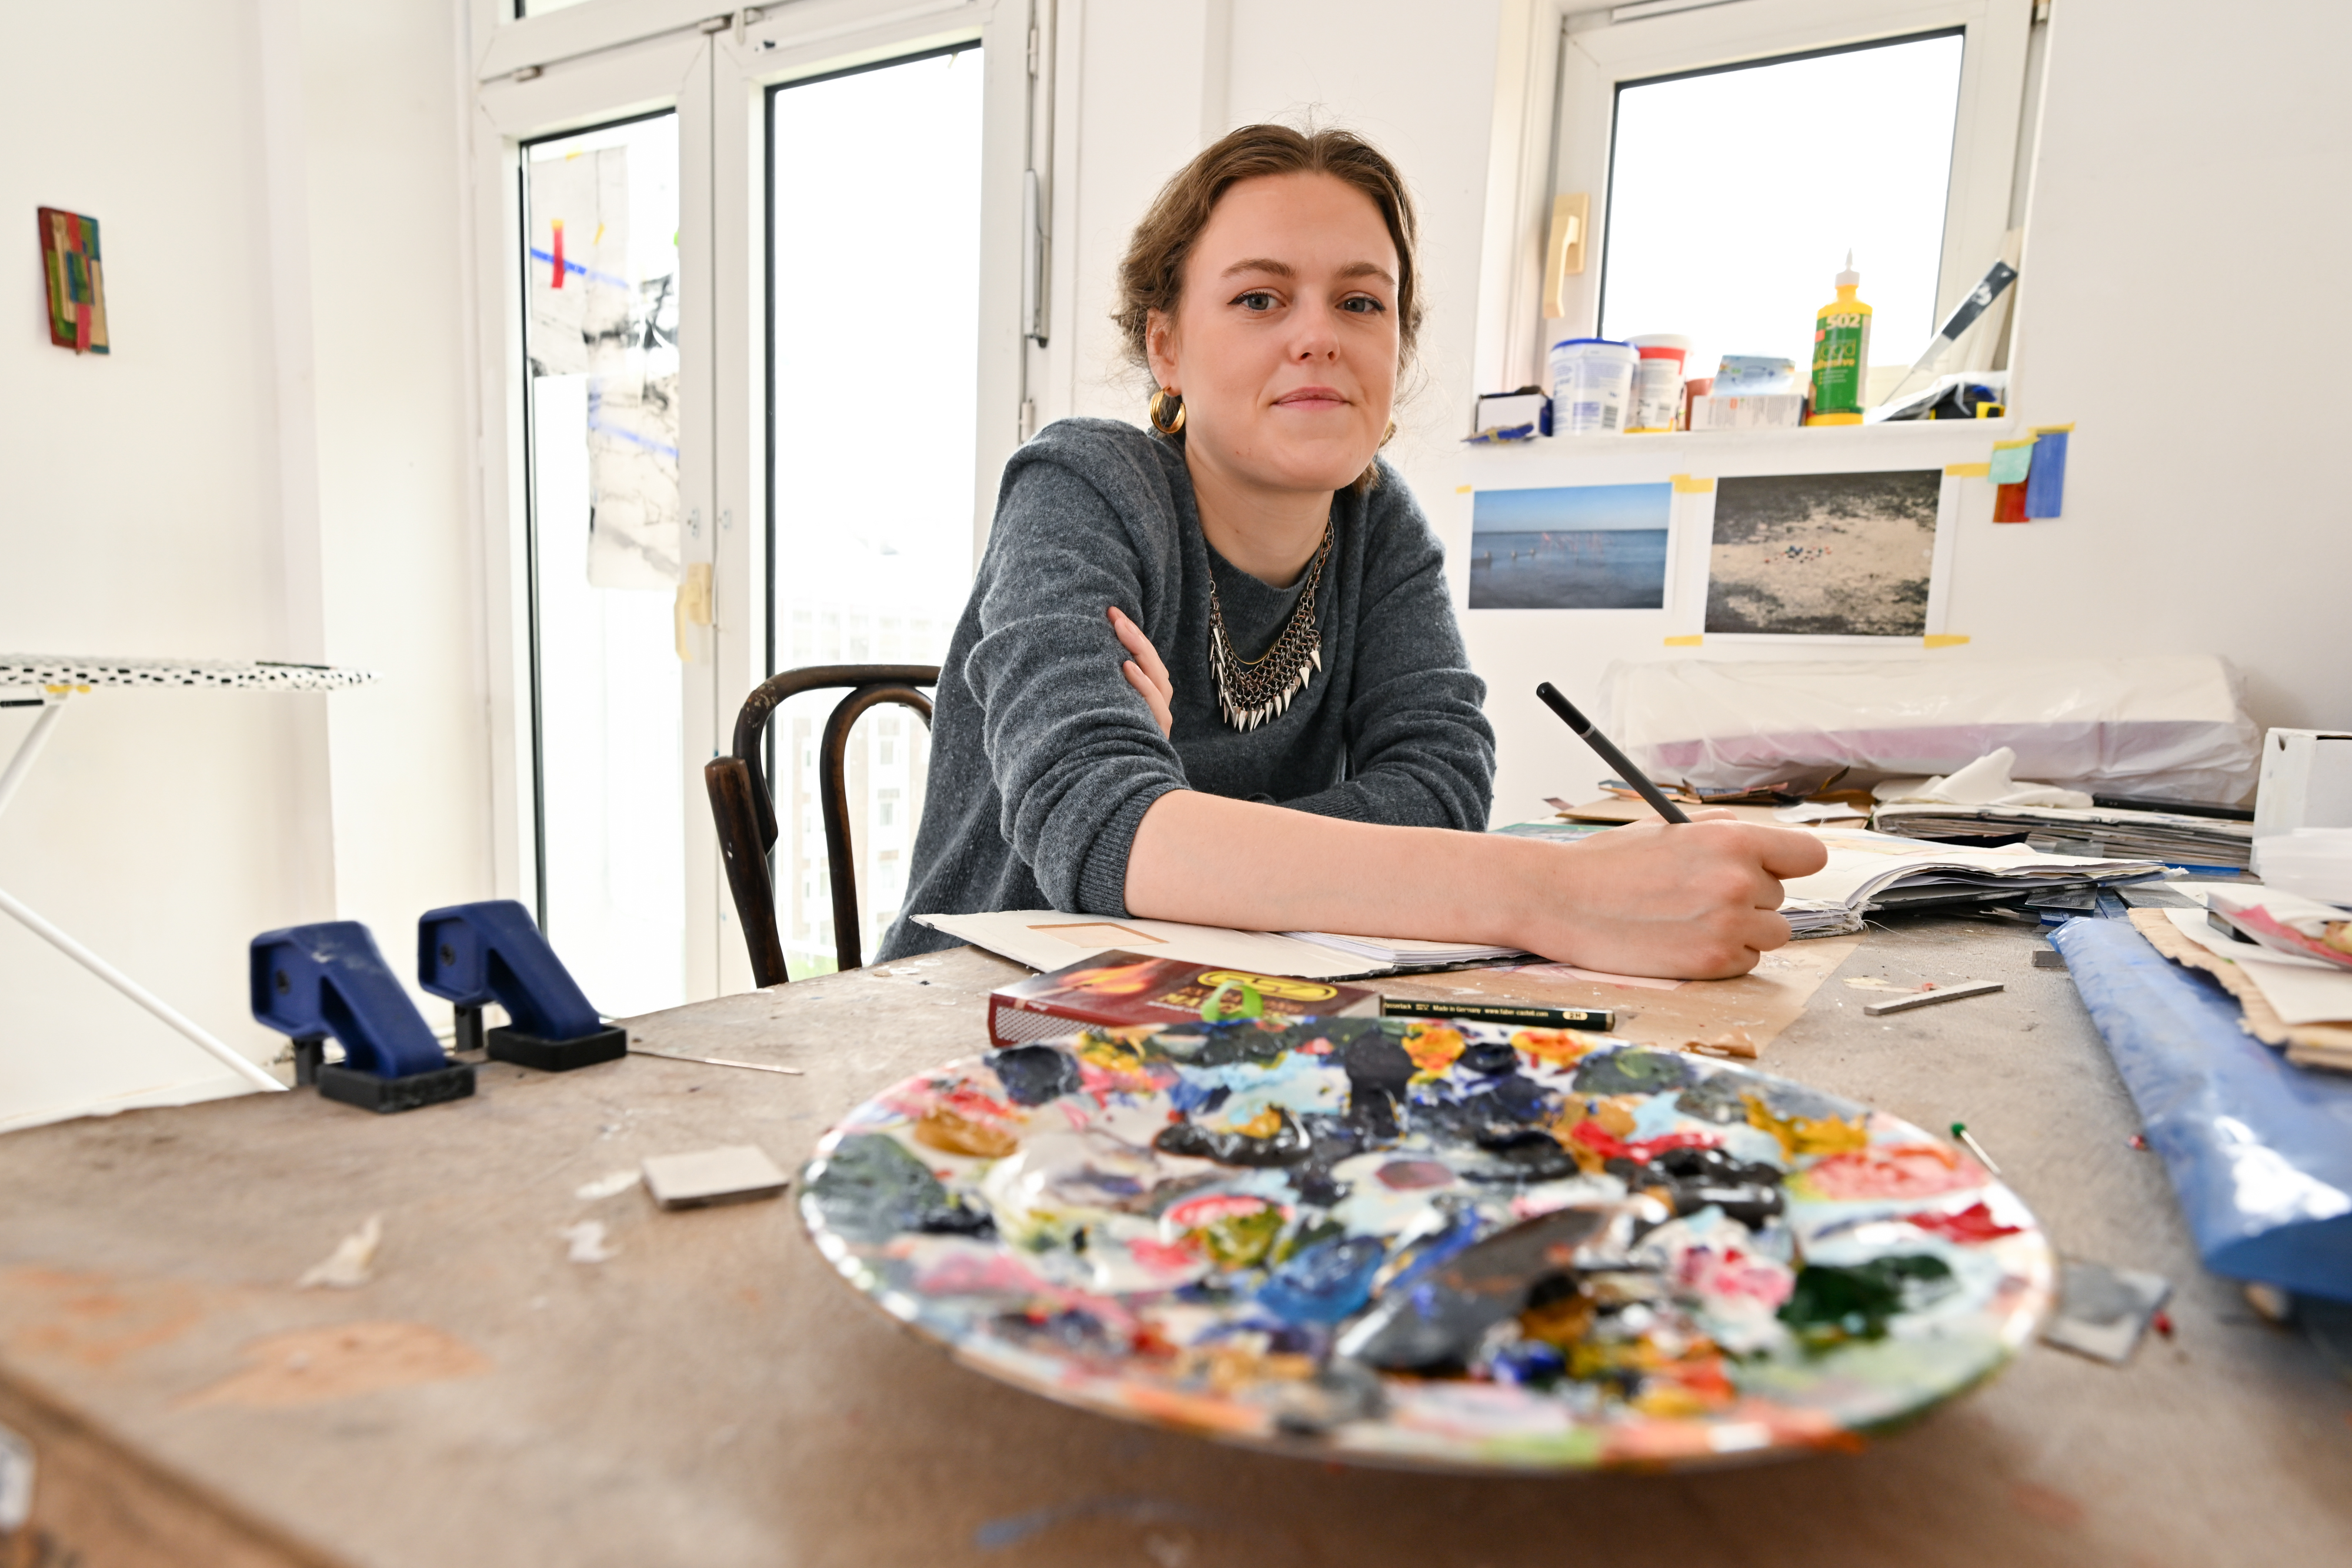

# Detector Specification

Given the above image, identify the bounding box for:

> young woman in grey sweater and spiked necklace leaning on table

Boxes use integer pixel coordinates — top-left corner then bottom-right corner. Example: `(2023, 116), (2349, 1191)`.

(882, 125), (1823, 978)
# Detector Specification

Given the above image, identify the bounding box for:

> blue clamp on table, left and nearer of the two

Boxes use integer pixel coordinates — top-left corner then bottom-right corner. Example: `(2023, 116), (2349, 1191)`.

(252, 919), (473, 1112)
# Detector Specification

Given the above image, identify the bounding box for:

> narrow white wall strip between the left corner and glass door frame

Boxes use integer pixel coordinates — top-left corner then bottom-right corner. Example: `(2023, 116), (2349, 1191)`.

(301, 0), (494, 1006)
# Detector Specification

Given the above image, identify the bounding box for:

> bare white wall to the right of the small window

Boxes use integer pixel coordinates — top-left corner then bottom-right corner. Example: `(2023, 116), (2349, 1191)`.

(1957, 0), (2352, 726)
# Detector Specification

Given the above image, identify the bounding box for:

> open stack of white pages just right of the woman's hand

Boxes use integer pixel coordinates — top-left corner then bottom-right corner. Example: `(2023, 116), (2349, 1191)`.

(1780, 828), (2164, 936)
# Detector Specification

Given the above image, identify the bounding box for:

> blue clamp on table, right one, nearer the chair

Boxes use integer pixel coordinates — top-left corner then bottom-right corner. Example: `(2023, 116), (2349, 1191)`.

(416, 898), (628, 1072)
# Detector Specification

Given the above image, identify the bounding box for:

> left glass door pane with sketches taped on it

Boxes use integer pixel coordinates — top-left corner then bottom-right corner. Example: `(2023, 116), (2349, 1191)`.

(520, 111), (689, 1016)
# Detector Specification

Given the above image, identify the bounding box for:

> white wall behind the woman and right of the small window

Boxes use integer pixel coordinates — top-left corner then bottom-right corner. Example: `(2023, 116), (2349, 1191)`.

(1040, 0), (2352, 820)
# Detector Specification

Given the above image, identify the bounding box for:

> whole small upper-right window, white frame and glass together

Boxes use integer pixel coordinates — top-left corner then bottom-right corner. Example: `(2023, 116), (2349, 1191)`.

(1533, 0), (2034, 411)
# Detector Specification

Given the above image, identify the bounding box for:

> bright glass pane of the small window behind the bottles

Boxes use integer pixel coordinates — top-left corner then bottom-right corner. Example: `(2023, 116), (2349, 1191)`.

(1599, 28), (1992, 376)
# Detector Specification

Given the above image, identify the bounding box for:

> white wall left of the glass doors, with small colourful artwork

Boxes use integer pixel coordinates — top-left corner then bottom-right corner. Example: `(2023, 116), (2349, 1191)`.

(0, 0), (489, 1129)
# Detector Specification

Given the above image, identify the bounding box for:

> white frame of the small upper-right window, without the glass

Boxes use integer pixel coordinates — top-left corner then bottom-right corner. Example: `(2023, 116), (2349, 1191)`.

(1479, 0), (2034, 391)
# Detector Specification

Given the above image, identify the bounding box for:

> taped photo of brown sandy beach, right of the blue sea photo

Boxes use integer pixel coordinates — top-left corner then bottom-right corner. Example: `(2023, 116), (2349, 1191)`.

(1703, 468), (1943, 637)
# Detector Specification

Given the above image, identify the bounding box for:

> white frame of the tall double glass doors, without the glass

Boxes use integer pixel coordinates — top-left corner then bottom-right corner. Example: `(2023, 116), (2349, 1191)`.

(468, 0), (1052, 999)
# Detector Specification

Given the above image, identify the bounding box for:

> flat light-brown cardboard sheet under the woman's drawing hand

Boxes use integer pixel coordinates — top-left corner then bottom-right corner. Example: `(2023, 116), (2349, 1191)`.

(1380, 936), (1863, 1058)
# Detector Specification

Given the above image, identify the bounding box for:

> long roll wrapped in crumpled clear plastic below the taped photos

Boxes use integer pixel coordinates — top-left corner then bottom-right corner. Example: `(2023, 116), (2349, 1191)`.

(1602, 653), (2263, 802)
